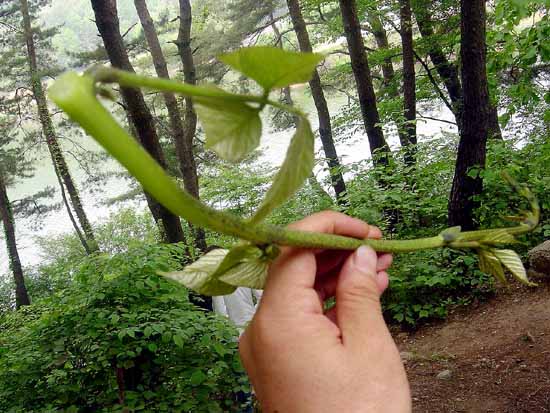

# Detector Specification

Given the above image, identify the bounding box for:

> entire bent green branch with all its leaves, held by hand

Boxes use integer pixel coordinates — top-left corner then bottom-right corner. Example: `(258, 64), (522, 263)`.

(49, 47), (540, 295)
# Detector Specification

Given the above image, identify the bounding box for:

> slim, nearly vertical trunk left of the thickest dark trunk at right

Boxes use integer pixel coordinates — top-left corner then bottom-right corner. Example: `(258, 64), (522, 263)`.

(399, 0), (417, 165)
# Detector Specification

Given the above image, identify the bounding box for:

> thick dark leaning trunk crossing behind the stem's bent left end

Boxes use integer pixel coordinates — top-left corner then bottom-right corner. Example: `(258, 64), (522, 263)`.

(91, 0), (185, 243)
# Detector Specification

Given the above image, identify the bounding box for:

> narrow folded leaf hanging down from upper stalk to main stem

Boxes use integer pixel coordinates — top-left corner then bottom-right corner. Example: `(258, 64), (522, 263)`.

(250, 118), (315, 223)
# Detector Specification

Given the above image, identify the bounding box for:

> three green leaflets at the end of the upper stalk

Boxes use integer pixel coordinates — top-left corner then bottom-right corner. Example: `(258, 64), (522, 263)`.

(195, 47), (323, 223)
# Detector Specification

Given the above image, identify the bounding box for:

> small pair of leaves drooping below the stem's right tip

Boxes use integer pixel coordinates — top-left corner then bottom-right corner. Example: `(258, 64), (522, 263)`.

(478, 249), (536, 286)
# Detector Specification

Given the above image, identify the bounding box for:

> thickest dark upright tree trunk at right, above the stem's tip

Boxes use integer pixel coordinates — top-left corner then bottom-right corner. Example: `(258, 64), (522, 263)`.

(449, 0), (490, 230)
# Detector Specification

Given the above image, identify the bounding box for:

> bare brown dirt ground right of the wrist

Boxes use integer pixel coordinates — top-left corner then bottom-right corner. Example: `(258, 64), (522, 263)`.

(396, 277), (550, 413)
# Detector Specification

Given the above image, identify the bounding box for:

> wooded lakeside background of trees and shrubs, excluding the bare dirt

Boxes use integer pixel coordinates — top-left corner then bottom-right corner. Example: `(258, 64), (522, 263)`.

(0, 0), (550, 411)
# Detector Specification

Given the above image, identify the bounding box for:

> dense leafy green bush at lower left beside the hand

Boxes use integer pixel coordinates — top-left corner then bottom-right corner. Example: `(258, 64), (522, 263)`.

(0, 245), (248, 412)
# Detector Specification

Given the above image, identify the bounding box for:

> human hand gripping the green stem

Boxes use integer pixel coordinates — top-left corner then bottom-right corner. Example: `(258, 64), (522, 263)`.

(240, 212), (411, 413)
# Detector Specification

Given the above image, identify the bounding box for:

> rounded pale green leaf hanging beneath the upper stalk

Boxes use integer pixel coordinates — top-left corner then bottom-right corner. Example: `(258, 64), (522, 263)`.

(195, 99), (262, 162)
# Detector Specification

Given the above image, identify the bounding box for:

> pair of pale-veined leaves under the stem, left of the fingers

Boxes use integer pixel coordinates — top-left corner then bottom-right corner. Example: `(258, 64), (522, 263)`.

(161, 244), (276, 296)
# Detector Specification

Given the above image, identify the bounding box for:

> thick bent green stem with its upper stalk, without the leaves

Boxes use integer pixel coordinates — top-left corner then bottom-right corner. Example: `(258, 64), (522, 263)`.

(49, 69), (540, 252)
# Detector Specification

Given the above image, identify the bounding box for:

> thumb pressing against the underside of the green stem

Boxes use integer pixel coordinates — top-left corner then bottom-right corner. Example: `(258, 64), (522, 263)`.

(336, 246), (387, 348)
